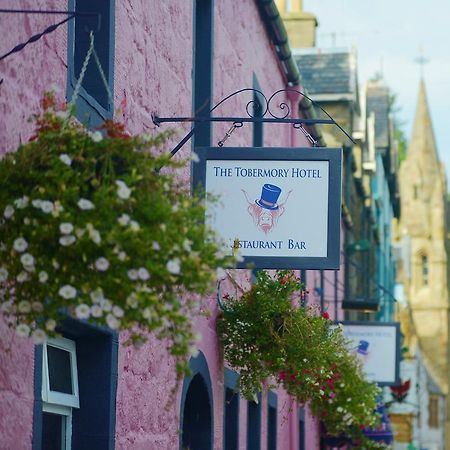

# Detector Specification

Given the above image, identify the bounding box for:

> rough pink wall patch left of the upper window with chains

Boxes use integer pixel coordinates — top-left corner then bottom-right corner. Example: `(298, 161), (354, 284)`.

(0, 0), (67, 157)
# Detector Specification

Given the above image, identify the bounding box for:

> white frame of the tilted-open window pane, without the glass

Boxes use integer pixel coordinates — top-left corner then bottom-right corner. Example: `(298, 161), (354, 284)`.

(42, 338), (80, 408)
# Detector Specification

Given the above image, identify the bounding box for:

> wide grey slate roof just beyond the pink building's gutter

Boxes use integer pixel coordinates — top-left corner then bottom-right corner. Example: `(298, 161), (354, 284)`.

(294, 51), (357, 95)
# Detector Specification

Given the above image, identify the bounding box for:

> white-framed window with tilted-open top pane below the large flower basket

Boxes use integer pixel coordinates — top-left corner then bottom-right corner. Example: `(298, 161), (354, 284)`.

(41, 338), (80, 450)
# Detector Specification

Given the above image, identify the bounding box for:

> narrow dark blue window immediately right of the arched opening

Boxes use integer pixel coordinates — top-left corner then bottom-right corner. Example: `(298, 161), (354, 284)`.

(223, 368), (239, 450)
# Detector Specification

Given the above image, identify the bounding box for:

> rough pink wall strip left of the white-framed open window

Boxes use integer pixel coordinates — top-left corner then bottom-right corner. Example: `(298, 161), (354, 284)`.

(0, 315), (34, 450)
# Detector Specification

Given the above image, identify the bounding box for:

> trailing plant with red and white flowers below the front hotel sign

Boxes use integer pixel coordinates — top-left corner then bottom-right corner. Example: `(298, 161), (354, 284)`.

(217, 270), (388, 448)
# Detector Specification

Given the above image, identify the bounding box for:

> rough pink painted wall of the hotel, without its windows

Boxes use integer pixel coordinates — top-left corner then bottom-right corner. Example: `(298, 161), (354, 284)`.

(0, 0), (343, 450)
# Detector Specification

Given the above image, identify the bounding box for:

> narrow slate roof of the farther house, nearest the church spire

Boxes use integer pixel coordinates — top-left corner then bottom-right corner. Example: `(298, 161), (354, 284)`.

(367, 83), (389, 148)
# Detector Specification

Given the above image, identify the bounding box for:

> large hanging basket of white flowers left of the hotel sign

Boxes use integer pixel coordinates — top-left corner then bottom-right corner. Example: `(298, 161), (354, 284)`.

(0, 94), (236, 375)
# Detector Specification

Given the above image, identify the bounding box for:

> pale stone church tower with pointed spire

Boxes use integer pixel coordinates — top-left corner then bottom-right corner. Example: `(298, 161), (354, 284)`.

(400, 80), (450, 440)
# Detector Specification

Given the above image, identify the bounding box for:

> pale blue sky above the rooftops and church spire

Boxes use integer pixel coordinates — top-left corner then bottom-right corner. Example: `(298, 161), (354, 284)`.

(300, 0), (450, 185)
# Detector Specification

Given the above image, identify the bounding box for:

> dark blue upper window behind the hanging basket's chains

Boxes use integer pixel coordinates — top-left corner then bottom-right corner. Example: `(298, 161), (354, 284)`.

(67, 0), (115, 127)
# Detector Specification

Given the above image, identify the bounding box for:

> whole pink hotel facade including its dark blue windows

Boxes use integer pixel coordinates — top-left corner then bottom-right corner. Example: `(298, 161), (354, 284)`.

(0, 0), (332, 450)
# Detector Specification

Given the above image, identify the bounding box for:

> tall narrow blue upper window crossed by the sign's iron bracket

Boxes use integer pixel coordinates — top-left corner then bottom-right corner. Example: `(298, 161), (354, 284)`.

(193, 0), (214, 147)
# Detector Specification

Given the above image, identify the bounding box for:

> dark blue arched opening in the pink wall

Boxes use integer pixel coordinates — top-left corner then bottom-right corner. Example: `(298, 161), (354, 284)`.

(179, 352), (214, 450)
